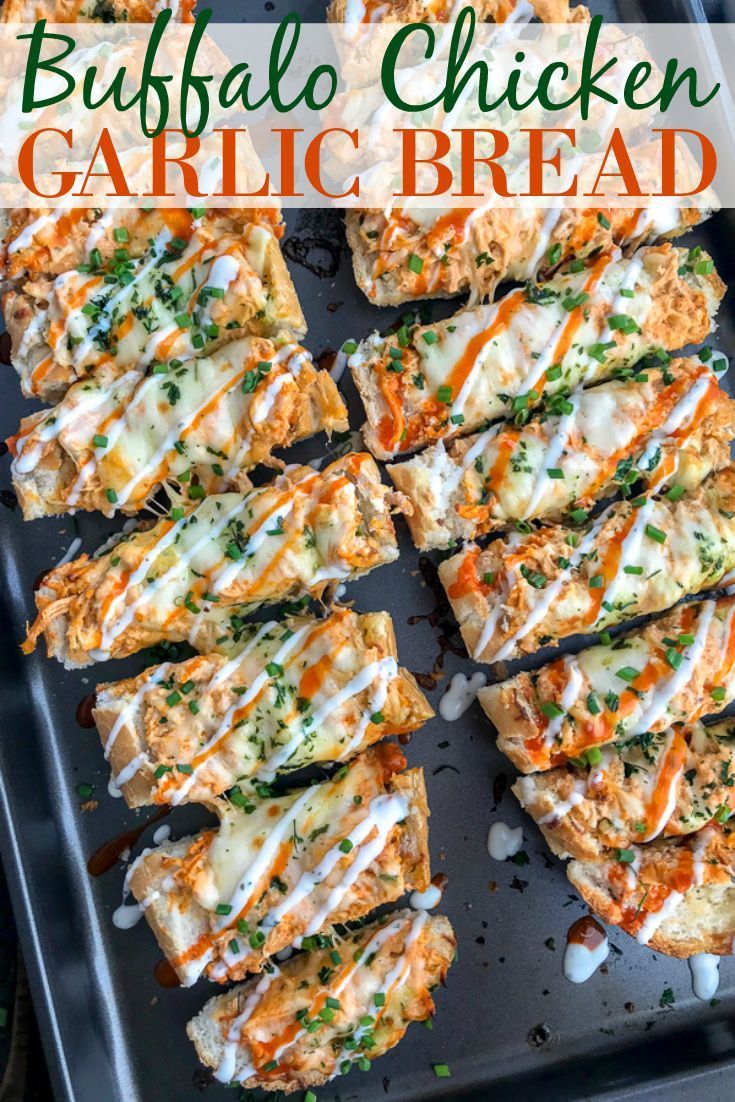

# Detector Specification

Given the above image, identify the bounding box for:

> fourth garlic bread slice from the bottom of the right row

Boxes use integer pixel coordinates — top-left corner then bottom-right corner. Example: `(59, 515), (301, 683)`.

(439, 466), (735, 662)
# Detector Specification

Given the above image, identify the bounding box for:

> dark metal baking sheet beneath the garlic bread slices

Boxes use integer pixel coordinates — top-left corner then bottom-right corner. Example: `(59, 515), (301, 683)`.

(0, 0), (735, 1102)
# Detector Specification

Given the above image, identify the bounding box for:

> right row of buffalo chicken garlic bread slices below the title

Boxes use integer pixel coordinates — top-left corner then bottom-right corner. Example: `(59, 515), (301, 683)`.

(319, 0), (735, 957)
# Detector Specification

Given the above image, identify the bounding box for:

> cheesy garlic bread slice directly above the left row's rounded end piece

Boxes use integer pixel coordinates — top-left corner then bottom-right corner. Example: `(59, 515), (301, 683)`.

(127, 743), (429, 986)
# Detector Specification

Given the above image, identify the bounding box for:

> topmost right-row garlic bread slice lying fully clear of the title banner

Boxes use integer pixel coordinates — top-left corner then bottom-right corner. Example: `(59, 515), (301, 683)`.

(349, 245), (725, 460)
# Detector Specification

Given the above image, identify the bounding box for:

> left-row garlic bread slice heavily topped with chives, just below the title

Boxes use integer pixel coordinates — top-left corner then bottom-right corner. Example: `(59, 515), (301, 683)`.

(3, 217), (305, 401)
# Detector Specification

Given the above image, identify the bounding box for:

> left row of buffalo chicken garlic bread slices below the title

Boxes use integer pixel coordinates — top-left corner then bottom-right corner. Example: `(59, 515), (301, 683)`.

(4, 12), (455, 1090)
